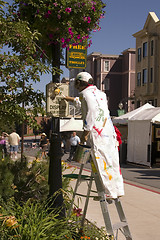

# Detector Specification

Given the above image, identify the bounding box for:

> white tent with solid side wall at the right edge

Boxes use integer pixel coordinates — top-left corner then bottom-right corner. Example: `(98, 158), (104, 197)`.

(127, 107), (160, 166)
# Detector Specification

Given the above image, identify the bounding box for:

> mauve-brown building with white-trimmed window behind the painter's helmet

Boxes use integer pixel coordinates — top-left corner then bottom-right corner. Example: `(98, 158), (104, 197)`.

(70, 48), (135, 116)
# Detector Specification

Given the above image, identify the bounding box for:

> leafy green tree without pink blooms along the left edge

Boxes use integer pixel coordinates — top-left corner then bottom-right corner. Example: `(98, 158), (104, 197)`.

(0, 1), (55, 130)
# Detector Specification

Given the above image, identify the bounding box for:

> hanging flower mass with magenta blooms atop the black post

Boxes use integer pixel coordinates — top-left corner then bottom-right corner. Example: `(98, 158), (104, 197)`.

(13, 0), (105, 57)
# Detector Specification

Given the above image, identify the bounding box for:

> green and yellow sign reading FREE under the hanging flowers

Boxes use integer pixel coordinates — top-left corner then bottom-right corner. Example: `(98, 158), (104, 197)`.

(66, 43), (87, 69)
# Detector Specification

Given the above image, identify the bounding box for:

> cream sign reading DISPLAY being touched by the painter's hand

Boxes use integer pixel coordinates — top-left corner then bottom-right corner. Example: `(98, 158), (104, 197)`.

(46, 83), (69, 117)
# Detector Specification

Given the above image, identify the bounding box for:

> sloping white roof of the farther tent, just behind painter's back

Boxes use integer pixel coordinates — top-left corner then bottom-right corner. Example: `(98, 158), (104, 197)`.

(113, 103), (154, 124)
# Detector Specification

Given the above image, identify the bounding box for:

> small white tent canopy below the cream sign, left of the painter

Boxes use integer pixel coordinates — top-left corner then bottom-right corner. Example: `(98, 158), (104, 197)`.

(60, 117), (83, 132)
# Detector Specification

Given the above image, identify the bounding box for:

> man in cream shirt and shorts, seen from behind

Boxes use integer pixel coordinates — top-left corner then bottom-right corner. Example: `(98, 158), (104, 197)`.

(8, 130), (20, 159)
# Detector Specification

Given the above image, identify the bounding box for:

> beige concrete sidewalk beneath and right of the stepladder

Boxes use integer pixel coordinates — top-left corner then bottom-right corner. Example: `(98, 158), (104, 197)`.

(65, 163), (160, 240)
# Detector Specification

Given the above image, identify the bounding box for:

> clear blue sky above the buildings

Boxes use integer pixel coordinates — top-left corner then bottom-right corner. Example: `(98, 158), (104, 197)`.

(5, 0), (160, 92)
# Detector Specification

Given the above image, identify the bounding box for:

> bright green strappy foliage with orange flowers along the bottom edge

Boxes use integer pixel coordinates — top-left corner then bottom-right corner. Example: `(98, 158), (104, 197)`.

(0, 198), (109, 240)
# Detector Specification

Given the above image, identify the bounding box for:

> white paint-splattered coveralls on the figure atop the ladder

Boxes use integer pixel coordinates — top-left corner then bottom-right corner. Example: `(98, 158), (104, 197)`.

(75, 86), (124, 198)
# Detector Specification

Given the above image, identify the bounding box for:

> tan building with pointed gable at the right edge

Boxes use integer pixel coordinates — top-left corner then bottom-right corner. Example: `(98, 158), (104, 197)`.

(133, 12), (160, 108)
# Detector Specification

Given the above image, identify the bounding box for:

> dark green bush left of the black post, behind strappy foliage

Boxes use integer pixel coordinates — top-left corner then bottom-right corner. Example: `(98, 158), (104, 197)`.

(0, 158), (48, 202)
